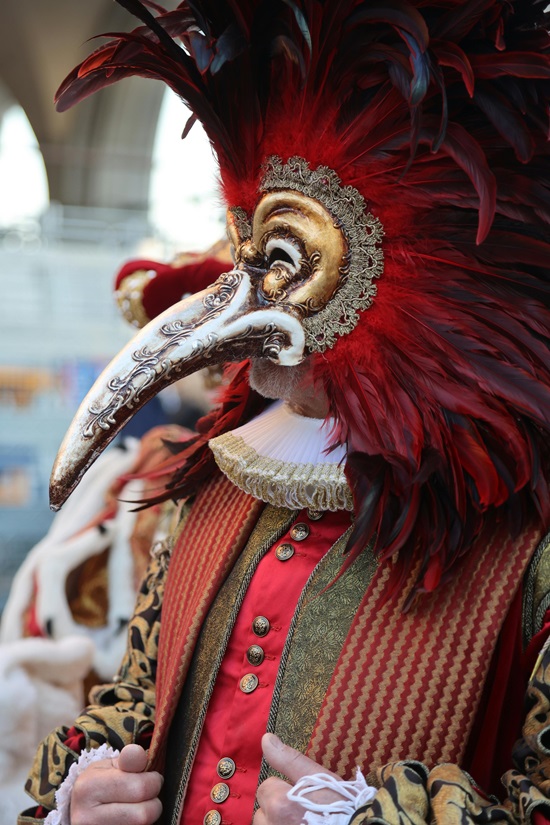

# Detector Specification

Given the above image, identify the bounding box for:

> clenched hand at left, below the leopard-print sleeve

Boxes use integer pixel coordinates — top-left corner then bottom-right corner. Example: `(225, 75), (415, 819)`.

(71, 745), (163, 825)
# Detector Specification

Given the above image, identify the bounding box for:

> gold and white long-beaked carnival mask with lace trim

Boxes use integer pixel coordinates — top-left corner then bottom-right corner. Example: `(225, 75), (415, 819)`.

(50, 157), (383, 502)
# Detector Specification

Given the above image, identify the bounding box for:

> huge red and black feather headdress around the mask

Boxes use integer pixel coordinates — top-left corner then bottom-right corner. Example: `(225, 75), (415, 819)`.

(58, 0), (550, 590)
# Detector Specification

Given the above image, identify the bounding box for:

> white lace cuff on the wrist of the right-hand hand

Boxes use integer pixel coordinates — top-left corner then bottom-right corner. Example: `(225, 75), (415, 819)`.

(287, 768), (376, 825)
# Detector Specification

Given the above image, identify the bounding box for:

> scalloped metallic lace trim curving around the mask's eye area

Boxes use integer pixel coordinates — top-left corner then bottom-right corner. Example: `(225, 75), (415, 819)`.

(261, 155), (384, 352)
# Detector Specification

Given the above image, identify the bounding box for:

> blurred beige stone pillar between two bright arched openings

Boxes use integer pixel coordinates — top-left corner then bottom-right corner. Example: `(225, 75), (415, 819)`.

(0, 0), (163, 210)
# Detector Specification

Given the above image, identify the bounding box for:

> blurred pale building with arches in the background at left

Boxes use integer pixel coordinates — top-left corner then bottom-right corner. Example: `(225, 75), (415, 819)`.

(0, 0), (224, 612)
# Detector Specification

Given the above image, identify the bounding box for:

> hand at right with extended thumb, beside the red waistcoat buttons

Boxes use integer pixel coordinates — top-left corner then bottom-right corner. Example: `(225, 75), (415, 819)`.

(253, 733), (341, 825)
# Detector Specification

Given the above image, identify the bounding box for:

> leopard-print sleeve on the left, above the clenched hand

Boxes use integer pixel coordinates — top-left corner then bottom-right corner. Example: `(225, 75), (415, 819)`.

(19, 543), (169, 823)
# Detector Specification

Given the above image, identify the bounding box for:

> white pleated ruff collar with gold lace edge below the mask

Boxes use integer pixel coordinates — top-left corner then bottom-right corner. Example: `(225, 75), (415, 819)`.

(209, 401), (353, 511)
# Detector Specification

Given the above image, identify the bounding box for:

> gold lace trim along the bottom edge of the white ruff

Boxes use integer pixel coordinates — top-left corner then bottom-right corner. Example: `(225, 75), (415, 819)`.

(209, 433), (353, 510)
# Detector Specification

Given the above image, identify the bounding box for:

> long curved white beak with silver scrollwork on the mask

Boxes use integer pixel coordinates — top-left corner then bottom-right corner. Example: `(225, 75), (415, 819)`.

(50, 270), (305, 510)
